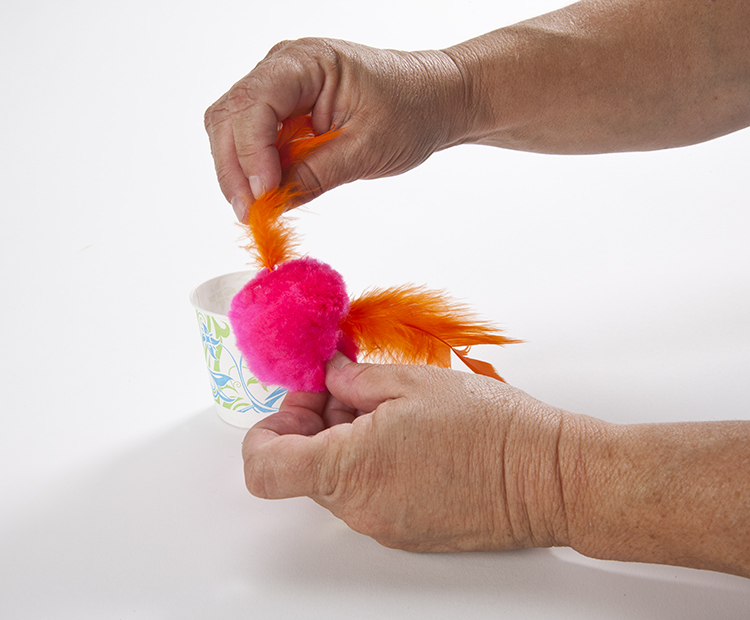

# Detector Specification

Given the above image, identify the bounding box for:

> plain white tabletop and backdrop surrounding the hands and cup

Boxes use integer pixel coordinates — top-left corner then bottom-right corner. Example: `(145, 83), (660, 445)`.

(0, 0), (750, 620)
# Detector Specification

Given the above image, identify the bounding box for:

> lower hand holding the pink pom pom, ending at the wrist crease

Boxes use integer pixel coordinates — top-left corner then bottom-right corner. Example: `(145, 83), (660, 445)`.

(243, 356), (567, 551)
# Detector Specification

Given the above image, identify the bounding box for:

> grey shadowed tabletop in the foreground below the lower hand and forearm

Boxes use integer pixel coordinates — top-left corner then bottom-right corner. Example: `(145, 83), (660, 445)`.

(0, 410), (750, 620)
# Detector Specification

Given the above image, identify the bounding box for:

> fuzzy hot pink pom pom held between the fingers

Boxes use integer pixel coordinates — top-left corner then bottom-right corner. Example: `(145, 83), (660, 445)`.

(229, 258), (356, 392)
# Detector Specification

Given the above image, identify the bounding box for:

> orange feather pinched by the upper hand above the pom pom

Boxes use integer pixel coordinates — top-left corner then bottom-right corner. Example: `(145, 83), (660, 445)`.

(245, 116), (340, 271)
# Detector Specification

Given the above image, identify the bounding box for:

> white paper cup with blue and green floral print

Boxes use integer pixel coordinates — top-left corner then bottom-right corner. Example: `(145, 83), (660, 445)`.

(190, 271), (286, 428)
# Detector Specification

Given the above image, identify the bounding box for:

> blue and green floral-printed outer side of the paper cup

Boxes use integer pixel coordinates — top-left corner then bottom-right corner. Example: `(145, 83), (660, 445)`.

(196, 311), (287, 415)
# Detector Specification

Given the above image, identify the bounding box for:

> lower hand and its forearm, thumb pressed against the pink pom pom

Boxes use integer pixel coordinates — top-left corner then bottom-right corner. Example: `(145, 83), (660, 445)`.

(243, 356), (750, 577)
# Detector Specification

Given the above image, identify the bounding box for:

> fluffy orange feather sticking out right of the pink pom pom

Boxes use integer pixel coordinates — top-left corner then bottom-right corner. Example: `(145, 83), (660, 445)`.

(341, 286), (519, 381)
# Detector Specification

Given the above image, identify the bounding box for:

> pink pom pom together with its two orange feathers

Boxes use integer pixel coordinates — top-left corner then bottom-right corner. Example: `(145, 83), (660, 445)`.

(229, 117), (516, 392)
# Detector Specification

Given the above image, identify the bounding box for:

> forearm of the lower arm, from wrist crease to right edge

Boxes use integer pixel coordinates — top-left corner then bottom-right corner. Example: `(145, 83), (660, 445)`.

(560, 416), (750, 576)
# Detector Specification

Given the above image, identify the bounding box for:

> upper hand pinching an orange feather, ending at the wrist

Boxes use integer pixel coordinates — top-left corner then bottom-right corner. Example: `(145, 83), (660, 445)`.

(205, 39), (471, 220)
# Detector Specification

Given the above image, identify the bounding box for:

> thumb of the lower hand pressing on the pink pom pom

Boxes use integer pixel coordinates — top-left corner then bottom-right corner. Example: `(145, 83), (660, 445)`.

(326, 353), (414, 413)
